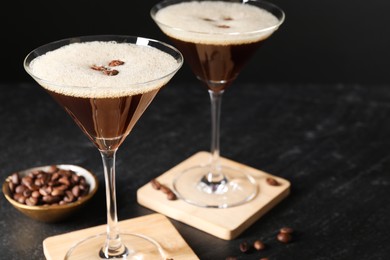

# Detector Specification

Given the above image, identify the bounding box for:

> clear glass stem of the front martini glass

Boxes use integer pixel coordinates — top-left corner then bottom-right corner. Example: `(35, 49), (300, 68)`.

(100, 150), (127, 259)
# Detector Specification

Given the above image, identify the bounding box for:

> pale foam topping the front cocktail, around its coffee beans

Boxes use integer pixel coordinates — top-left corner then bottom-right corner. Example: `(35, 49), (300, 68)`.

(29, 41), (180, 98)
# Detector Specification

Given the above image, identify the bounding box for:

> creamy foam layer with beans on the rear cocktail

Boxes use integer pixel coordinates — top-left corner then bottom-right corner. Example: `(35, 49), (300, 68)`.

(154, 1), (281, 45)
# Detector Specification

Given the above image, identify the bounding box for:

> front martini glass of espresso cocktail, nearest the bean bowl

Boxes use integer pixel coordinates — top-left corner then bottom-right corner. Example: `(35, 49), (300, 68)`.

(24, 35), (183, 259)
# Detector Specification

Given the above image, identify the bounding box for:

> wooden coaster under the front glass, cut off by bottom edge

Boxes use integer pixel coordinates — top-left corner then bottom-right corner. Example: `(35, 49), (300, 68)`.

(43, 213), (199, 260)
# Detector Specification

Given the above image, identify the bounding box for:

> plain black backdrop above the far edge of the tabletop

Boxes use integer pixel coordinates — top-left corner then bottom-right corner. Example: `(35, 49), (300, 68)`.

(0, 0), (390, 85)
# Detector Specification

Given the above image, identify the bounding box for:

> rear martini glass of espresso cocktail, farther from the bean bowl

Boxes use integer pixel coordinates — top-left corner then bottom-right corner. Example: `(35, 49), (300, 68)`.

(150, 0), (285, 208)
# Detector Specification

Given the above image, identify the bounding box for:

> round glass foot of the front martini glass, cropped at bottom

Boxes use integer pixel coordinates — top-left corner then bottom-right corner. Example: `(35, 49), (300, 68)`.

(64, 233), (166, 260)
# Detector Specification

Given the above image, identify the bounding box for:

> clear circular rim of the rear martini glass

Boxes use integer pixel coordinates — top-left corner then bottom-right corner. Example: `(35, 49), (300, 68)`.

(150, 0), (286, 36)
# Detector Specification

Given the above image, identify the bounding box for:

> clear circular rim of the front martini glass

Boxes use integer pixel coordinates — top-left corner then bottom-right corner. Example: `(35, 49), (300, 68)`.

(23, 34), (184, 89)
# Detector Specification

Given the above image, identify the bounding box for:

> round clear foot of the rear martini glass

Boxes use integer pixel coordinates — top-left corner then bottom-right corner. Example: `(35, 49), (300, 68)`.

(173, 165), (258, 208)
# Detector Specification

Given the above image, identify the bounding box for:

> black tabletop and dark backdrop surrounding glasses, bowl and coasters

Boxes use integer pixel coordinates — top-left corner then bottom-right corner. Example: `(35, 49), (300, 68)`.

(0, 0), (390, 260)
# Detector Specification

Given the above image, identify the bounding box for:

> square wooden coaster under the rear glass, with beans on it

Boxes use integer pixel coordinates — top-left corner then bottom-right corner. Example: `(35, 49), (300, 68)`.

(137, 152), (290, 240)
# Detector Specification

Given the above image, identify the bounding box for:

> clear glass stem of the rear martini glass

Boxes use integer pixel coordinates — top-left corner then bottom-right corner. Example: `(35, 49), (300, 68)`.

(206, 90), (225, 184)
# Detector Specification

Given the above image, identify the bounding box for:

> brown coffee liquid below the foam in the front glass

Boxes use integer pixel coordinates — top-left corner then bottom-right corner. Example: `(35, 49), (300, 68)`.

(48, 88), (159, 150)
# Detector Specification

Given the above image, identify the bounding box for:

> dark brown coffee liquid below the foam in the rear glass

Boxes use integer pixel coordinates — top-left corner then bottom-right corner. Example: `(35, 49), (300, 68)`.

(170, 37), (263, 91)
